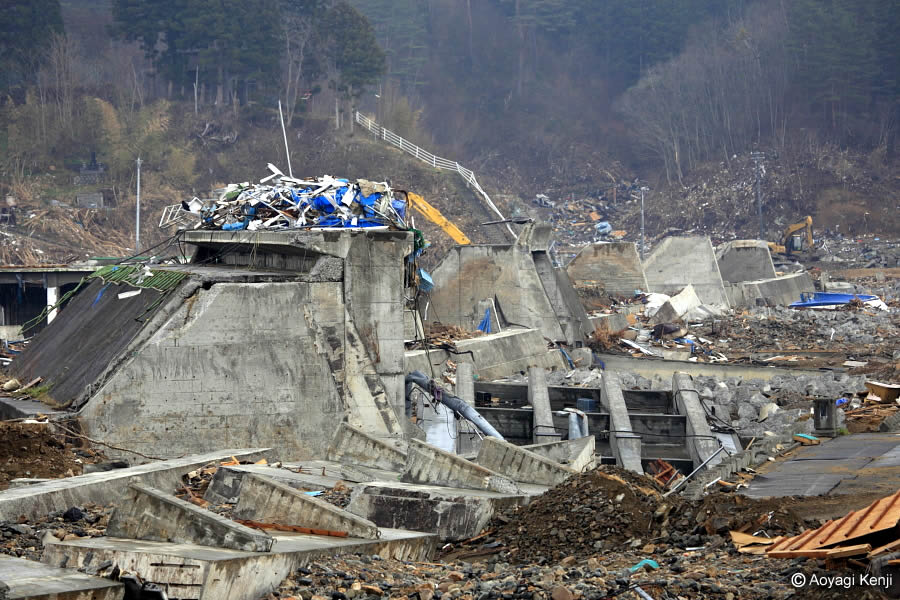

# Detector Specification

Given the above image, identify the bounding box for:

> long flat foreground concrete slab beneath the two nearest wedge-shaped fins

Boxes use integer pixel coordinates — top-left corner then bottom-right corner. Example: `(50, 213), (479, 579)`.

(42, 529), (437, 600)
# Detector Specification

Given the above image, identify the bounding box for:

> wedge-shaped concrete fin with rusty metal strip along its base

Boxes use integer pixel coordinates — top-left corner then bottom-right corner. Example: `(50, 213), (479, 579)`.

(234, 474), (380, 540)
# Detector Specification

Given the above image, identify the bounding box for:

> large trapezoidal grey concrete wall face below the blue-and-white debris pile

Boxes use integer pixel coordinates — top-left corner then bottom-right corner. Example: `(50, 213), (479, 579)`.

(79, 282), (344, 458)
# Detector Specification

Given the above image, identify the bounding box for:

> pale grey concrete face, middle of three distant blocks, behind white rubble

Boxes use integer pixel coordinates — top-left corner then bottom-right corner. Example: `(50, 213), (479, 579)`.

(644, 236), (729, 307)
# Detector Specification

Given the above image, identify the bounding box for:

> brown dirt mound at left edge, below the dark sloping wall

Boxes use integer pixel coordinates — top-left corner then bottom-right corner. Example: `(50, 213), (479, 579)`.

(0, 421), (94, 489)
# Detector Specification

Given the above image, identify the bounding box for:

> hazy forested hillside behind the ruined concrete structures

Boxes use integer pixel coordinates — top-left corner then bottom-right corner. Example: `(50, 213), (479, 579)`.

(0, 0), (900, 258)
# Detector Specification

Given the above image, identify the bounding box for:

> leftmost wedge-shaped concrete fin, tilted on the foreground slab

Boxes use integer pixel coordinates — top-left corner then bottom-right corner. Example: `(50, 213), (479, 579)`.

(106, 483), (274, 552)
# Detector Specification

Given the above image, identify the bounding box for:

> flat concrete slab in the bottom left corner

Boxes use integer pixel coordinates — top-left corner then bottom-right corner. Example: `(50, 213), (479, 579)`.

(0, 555), (125, 600)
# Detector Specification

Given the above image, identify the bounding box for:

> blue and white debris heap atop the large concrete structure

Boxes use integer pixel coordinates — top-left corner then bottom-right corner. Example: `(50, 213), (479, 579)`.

(159, 164), (406, 231)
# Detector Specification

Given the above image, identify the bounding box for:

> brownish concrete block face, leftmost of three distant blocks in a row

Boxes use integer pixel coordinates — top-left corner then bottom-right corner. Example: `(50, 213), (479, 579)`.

(566, 242), (648, 298)
